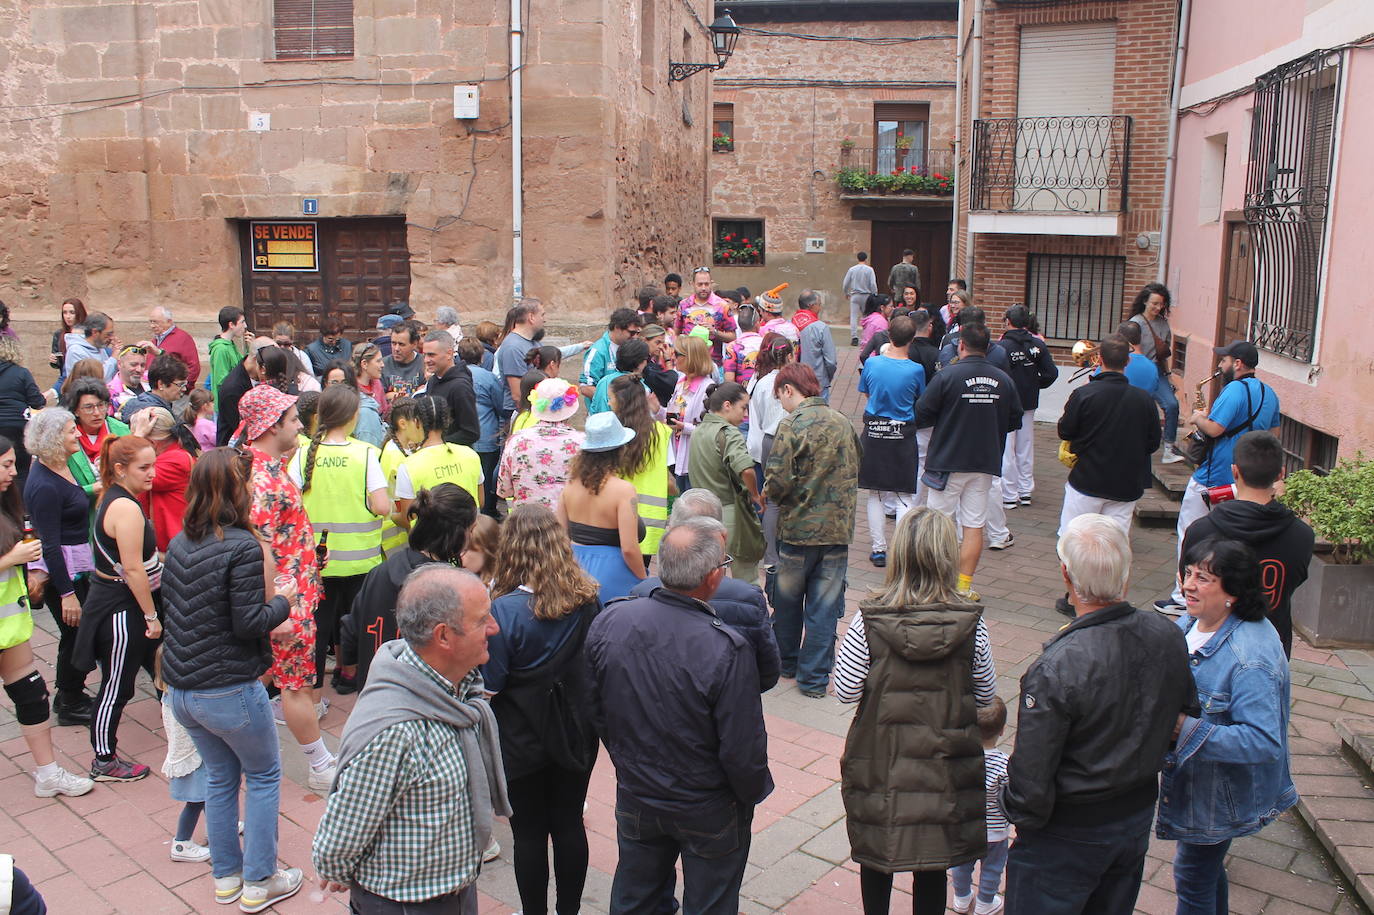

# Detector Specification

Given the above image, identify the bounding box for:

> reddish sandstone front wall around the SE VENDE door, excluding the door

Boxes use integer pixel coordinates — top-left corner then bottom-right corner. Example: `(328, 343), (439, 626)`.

(0, 0), (708, 329)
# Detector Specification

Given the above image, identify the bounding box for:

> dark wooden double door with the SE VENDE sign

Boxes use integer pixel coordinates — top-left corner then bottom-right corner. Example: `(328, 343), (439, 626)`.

(239, 216), (411, 341)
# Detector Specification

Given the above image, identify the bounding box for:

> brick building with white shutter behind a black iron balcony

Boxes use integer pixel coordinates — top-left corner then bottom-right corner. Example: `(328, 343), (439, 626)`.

(956, 0), (1181, 351)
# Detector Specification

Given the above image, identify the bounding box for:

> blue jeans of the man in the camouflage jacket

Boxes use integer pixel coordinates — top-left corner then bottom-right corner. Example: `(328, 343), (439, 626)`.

(774, 541), (849, 692)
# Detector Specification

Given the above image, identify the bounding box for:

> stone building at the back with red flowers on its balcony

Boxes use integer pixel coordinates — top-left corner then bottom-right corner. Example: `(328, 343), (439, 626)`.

(709, 0), (958, 331)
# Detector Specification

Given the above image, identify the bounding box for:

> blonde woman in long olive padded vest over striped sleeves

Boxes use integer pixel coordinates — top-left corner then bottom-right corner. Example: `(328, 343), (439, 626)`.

(834, 507), (996, 915)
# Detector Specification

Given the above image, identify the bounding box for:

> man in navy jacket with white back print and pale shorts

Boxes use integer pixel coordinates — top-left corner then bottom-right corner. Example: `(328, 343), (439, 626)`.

(916, 322), (1021, 600)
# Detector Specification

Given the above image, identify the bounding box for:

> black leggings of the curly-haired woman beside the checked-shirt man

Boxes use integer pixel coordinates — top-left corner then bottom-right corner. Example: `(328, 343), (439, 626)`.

(507, 765), (592, 915)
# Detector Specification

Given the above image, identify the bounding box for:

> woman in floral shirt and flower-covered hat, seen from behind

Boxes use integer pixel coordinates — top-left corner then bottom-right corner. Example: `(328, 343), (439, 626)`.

(496, 378), (583, 511)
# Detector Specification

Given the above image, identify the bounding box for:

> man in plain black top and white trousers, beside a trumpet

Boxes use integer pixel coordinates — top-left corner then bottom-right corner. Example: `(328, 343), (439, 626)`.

(1059, 337), (1160, 536)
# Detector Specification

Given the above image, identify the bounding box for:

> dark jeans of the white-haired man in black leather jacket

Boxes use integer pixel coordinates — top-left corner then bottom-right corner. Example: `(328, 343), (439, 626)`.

(1007, 805), (1154, 915)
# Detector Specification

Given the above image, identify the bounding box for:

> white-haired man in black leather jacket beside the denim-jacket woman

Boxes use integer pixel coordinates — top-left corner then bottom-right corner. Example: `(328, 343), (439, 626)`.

(1003, 514), (1197, 915)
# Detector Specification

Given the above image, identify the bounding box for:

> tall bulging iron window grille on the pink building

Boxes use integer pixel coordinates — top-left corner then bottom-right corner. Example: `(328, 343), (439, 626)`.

(1245, 51), (1341, 361)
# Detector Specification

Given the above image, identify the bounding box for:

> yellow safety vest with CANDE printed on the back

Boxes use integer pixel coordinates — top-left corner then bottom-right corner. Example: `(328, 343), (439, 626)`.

(291, 438), (382, 578)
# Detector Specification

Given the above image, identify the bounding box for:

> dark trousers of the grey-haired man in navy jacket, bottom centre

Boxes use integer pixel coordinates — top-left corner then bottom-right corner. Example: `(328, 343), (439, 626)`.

(610, 794), (754, 915)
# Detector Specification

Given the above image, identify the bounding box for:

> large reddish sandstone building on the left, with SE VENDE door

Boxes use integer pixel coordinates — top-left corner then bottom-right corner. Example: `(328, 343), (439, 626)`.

(0, 0), (712, 370)
